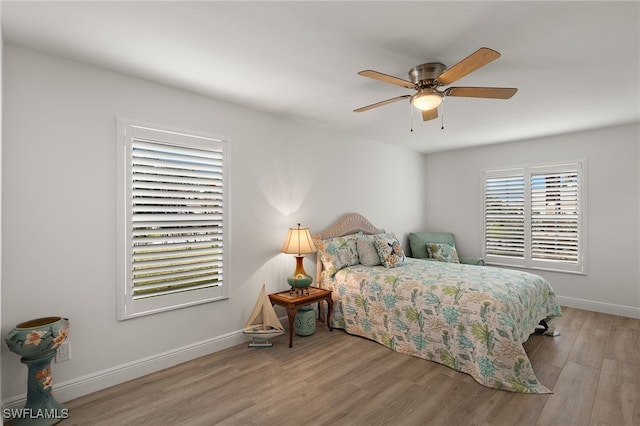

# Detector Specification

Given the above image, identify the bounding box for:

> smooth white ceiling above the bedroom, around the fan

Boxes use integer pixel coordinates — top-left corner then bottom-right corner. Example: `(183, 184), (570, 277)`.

(1, 1), (640, 152)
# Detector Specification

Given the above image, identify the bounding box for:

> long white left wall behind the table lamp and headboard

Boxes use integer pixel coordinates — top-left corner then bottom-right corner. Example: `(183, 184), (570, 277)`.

(1, 45), (425, 405)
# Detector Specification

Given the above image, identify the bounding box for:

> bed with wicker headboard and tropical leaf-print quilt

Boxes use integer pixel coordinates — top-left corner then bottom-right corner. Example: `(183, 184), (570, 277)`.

(314, 213), (562, 393)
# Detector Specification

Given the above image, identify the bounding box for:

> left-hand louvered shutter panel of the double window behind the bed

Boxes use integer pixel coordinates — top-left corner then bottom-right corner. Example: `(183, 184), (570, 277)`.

(484, 175), (525, 259)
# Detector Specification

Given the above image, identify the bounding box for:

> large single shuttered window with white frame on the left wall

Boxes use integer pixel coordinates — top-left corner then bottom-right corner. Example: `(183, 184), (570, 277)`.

(116, 120), (229, 320)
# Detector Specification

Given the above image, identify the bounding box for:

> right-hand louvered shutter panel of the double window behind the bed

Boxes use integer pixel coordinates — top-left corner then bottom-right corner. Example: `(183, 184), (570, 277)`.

(531, 170), (580, 263)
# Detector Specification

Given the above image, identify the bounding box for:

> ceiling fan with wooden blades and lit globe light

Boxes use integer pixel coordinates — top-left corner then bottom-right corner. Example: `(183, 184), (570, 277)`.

(354, 47), (518, 121)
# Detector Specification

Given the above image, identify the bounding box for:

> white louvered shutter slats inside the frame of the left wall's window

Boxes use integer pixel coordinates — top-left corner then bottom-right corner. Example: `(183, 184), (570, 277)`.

(131, 139), (224, 300)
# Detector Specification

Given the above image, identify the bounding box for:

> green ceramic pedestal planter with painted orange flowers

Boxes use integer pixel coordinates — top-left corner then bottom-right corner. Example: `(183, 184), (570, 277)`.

(5, 317), (69, 426)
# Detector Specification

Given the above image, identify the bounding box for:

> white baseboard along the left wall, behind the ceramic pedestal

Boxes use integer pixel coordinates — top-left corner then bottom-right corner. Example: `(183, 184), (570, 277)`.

(2, 330), (247, 409)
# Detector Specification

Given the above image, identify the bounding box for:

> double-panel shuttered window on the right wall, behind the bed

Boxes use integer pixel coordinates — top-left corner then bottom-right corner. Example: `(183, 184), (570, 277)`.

(484, 163), (586, 273)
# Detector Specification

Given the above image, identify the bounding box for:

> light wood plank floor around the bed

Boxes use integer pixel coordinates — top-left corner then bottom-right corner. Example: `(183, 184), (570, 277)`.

(59, 308), (640, 426)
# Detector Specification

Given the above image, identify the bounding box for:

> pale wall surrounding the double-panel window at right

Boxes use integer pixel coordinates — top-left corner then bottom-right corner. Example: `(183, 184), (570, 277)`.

(425, 124), (640, 318)
